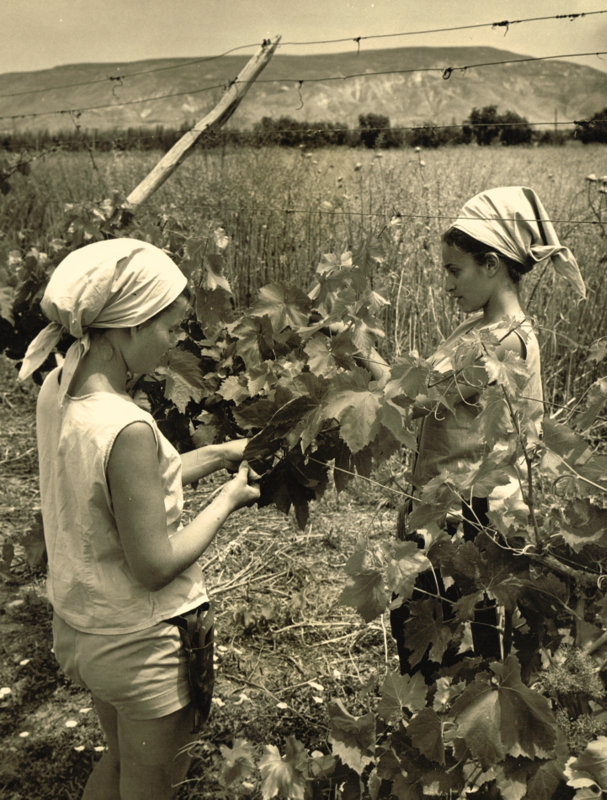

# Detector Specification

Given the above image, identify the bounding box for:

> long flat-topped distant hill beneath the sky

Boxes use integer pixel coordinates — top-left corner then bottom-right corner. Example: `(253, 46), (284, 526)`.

(0, 47), (607, 131)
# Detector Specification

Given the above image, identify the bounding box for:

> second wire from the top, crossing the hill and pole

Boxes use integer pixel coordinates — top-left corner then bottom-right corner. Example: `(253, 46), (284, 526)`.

(0, 50), (607, 120)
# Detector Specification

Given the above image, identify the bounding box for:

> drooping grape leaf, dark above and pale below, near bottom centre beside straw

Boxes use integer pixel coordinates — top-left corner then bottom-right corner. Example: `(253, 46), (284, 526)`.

(327, 700), (375, 775)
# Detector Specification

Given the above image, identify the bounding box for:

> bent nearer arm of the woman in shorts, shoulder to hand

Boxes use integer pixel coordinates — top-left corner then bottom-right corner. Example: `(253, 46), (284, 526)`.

(107, 422), (259, 591)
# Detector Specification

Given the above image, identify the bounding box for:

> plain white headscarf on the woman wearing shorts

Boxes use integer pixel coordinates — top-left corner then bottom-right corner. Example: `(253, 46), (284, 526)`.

(19, 238), (187, 401)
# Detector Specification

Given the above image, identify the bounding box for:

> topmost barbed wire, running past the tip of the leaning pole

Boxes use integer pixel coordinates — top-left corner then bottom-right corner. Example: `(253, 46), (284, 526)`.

(0, 9), (607, 98)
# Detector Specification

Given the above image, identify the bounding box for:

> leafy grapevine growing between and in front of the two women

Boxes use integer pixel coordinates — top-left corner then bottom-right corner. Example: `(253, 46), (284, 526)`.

(0, 194), (607, 800)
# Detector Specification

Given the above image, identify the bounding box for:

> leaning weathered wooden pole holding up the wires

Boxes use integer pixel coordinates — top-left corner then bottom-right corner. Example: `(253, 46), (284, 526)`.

(122, 36), (280, 218)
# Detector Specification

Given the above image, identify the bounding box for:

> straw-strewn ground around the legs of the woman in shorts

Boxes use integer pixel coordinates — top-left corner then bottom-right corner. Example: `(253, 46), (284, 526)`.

(0, 359), (397, 800)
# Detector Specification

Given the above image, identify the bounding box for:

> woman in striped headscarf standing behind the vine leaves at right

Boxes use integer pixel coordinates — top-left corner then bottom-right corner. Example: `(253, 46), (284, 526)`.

(356, 186), (585, 681)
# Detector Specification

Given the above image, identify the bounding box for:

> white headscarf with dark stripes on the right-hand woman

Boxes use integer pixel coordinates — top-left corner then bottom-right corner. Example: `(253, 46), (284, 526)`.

(452, 186), (586, 297)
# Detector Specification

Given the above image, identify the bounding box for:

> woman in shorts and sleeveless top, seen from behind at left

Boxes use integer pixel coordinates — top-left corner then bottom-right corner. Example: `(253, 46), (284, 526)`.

(20, 239), (259, 800)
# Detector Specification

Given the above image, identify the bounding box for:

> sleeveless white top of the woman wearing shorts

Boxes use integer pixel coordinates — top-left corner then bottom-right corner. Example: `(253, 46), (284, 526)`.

(37, 368), (207, 634)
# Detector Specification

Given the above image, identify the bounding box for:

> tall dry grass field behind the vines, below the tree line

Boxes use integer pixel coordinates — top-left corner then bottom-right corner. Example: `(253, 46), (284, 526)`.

(0, 143), (607, 402)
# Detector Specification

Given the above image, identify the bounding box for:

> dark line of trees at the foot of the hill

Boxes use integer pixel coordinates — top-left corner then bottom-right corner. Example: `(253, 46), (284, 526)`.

(0, 105), (607, 152)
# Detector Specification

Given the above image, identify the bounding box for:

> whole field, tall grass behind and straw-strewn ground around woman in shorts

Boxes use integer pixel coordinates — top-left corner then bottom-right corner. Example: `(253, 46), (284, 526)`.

(0, 145), (607, 800)
